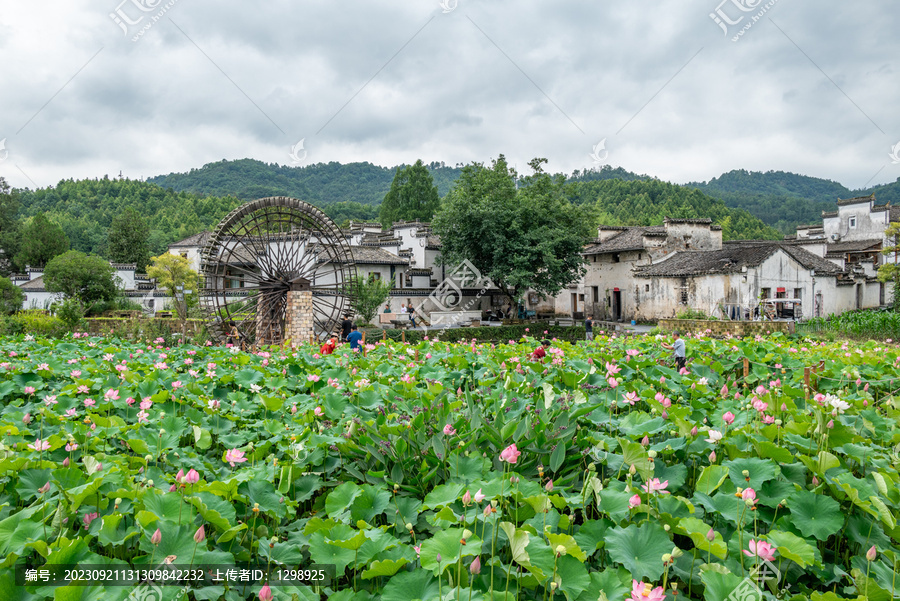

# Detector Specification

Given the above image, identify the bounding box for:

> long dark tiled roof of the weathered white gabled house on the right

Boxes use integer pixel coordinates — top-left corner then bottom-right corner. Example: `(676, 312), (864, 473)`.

(634, 241), (842, 278)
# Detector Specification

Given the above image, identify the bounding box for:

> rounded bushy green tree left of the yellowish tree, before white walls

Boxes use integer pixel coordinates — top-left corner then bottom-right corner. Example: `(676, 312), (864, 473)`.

(44, 250), (119, 309)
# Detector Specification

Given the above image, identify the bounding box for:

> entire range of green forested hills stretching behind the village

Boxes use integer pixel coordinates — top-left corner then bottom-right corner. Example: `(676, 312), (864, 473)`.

(8, 159), (900, 262)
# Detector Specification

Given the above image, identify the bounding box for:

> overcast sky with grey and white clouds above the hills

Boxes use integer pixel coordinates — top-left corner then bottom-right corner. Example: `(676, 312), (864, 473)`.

(0, 0), (900, 189)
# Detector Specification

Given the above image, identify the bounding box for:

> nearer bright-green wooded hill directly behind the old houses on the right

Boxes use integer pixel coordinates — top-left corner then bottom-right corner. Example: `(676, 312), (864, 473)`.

(566, 179), (781, 240)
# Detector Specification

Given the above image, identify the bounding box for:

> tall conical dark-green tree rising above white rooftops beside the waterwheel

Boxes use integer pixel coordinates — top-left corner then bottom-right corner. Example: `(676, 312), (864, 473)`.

(378, 159), (441, 227)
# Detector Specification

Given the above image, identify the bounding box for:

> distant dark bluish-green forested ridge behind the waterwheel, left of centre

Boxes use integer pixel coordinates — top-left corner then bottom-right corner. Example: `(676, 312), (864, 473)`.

(147, 159), (461, 207)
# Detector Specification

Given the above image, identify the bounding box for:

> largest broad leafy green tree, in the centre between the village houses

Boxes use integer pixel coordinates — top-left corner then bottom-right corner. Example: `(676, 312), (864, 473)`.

(433, 155), (593, 301)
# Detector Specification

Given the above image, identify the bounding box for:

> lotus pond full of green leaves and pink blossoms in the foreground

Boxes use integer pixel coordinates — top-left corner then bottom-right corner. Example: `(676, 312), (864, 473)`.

(0, 335), (900, 601)
